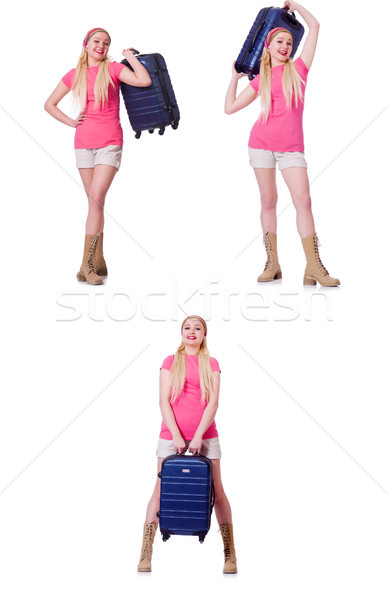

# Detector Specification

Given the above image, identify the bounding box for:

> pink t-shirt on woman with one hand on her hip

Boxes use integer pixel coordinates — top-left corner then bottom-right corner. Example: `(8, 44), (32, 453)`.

(62, 61), (125, 148)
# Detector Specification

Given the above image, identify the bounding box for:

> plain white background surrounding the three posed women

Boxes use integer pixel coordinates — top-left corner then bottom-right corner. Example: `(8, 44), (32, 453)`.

(0, 0), (388, 600)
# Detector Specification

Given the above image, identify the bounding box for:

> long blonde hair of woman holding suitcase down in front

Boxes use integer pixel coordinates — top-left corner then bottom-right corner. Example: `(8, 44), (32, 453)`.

(170, 337), (214, 404)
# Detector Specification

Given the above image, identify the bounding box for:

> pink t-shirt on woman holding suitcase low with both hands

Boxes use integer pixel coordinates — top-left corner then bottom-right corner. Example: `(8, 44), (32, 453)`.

(159, 354), (221, 440)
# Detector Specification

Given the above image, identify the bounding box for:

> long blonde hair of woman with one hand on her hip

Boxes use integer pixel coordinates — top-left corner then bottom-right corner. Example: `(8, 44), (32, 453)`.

(71, 48), (116, 111)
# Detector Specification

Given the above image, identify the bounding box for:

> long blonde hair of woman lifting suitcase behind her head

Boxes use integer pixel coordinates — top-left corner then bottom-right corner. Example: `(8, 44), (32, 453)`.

(258, 47), (305, 123)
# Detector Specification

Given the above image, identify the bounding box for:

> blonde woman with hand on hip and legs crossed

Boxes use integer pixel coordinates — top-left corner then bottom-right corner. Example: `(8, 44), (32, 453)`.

(44, 27), (151, 285)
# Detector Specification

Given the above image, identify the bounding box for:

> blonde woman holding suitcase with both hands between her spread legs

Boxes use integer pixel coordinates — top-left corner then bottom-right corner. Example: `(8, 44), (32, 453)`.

(138, 315), (237, 573)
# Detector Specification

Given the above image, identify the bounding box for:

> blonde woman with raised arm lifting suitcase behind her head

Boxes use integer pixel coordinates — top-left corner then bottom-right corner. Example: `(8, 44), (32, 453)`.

(225, 0), (340, 286)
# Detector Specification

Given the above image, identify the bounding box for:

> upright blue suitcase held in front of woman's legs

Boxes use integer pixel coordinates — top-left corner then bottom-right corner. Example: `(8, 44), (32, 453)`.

(158, 454), (215, 543)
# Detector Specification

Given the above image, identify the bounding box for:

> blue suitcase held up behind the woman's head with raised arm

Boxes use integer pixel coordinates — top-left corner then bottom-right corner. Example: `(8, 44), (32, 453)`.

(235, 6), (304, 79)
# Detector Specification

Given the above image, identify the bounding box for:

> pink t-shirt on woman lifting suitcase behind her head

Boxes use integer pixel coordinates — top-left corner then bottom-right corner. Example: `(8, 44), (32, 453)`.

(248, 58), (308, 152)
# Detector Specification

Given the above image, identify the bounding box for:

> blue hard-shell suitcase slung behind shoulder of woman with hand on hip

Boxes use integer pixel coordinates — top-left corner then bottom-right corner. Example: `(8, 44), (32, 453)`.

(120, 51), (180, 138)
